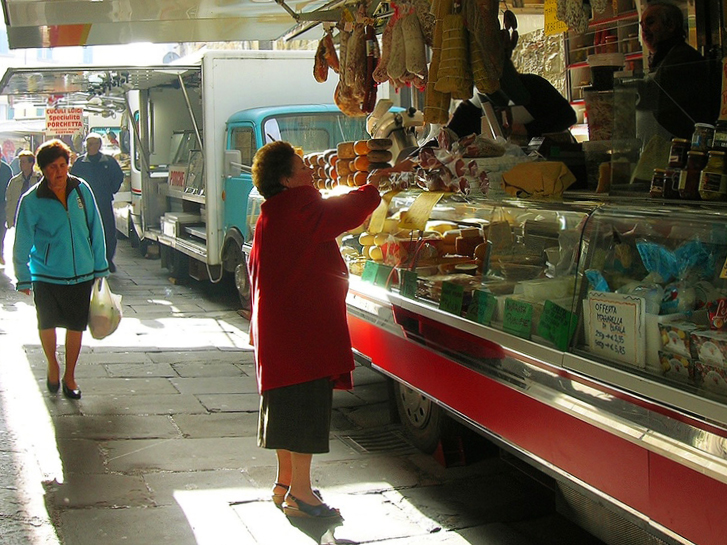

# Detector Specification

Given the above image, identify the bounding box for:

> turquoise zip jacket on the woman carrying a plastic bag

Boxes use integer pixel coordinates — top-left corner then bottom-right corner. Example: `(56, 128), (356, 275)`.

(13, 175), (109, 290)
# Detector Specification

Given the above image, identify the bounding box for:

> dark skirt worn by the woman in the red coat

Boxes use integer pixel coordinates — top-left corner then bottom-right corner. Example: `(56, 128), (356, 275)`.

(257, 378), (333, 454)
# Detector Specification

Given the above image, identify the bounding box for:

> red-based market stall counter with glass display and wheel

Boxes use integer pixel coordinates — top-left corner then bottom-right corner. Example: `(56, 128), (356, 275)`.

(341, 187), (727, 544)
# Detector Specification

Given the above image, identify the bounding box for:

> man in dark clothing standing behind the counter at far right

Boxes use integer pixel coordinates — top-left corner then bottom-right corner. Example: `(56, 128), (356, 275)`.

(637, 1), (721, 140)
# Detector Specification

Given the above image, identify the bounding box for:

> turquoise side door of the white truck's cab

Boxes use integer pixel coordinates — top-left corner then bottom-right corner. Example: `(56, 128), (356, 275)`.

(224, 122), (258, 241)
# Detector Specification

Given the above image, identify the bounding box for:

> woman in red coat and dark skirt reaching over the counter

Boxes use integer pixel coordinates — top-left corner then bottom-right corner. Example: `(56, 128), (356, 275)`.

(249, 138), (380, 518)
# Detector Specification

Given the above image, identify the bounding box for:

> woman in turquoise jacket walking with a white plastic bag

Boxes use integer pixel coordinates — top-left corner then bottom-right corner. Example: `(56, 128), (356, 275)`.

(13, 140), (109, 399)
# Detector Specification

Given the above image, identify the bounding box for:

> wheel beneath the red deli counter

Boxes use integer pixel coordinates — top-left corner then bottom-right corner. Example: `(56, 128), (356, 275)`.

(394, 382), (451, 454)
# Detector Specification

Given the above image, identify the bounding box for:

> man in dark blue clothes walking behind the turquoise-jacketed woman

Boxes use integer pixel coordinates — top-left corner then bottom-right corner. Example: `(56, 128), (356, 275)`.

(71, 132), (124, 272)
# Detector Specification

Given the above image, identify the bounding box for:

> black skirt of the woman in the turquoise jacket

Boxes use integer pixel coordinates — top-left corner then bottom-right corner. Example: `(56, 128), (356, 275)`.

(33, 280), (93, 331)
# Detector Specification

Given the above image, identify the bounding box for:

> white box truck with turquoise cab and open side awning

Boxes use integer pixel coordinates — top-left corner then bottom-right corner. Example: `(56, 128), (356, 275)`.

(0, 51), (366, 304)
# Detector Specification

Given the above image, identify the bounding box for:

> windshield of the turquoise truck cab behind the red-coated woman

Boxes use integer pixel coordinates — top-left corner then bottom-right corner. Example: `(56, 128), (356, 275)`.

(263, 112), (369, 153)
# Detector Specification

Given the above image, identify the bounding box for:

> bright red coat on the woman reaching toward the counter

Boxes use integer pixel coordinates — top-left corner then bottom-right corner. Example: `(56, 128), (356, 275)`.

(249, 186), (380, 392)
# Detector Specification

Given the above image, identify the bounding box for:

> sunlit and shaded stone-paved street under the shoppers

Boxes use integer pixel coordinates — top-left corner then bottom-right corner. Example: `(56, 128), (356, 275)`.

(0, 241), (595, 545)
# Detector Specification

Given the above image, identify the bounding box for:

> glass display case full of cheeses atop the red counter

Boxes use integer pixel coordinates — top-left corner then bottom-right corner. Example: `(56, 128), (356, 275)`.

(341, 191), (727, 425)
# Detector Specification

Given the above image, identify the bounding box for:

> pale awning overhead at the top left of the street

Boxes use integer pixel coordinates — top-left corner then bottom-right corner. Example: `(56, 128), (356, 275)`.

(2, 0), (352, 49)
